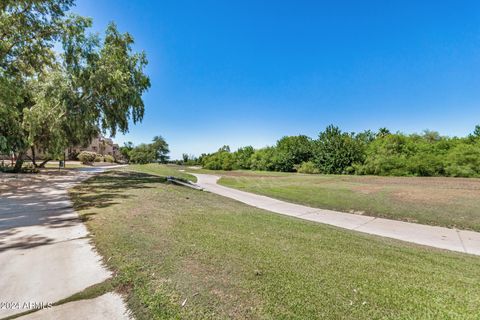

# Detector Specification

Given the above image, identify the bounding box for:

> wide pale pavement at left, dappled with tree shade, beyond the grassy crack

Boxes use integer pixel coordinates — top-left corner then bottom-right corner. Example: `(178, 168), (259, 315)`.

(0, 168), (129, 319)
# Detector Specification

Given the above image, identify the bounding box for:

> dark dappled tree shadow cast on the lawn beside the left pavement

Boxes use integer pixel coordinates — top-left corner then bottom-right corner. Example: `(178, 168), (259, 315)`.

(70, 171), (167, 214)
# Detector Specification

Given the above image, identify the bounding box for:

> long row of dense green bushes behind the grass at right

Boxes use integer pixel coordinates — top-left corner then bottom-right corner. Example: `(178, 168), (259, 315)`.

(198, 126), (480, 177)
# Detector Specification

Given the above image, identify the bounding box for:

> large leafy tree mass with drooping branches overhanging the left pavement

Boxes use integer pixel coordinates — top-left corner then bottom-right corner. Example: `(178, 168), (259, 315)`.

(0, 0), (150, 170)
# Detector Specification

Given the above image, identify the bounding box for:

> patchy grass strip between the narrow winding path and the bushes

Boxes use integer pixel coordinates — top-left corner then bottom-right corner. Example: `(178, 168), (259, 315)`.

(206, 170), (480, 231)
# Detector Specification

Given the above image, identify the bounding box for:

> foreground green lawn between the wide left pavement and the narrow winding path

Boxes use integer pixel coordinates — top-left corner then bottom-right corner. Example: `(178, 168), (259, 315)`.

(71, 166), (480, 319)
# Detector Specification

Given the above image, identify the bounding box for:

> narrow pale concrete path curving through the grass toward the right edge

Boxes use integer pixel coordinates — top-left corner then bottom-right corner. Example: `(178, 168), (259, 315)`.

(190, 173), (480, 255)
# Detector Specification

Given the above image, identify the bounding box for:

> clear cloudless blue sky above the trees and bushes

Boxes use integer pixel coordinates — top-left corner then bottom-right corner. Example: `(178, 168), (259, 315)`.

(72, 0), (480, 158)
